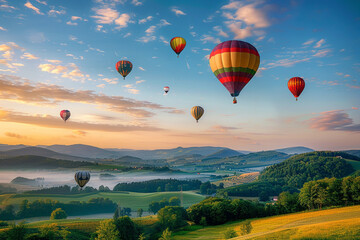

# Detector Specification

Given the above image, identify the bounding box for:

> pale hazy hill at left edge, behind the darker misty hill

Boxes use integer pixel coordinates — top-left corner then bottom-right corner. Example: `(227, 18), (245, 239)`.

(0, 147), (92, 161)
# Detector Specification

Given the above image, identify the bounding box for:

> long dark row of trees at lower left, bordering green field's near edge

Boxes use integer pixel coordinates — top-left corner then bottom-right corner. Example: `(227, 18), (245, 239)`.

(0, 198), (117, 220)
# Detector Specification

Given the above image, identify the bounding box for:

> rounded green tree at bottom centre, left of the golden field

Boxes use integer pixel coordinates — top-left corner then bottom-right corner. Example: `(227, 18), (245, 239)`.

(158, 206), (187, 230)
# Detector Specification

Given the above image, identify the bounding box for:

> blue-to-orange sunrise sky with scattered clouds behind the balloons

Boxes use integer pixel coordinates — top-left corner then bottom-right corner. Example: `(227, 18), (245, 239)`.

(0, 0), (360, 151)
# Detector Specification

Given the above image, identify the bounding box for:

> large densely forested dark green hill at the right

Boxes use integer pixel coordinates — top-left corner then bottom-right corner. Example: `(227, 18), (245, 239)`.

(259, 151), (360, 188)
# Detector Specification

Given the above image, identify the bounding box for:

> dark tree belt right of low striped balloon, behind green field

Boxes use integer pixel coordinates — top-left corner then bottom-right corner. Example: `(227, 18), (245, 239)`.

(114, 179), (201, 193)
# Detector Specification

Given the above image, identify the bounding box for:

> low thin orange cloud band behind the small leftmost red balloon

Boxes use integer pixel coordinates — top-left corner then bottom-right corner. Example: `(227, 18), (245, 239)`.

(0, 109), (162, 134)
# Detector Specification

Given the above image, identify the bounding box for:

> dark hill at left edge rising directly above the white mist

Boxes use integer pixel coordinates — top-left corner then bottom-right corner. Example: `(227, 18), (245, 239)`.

(0, 155), (95, 170)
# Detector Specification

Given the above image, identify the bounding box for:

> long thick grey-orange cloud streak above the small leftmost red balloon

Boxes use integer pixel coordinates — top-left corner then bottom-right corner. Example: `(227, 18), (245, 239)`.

(0, 74), (180, 118)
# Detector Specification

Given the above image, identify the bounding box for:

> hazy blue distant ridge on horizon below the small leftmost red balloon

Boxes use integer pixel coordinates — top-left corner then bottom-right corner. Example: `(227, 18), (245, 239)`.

(41, 144), (120, 158)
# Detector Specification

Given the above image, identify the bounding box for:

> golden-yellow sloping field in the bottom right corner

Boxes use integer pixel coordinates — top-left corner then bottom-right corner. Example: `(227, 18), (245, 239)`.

(173, 206), (360, 240)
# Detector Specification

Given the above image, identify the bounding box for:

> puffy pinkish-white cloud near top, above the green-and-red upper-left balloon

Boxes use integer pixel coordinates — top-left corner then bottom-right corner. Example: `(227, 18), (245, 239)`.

(92, 8), (130, 28)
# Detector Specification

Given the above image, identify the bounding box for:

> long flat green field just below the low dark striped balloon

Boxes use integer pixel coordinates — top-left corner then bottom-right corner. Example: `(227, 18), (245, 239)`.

(0, 191), (205, 211)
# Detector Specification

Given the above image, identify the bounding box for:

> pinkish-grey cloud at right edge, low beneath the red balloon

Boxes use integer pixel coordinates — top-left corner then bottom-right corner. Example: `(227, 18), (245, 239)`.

(308, 110), (360, 132)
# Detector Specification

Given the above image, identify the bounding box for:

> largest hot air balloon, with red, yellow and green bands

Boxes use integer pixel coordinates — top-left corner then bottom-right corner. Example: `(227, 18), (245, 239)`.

(209, 40), (260, 104)
